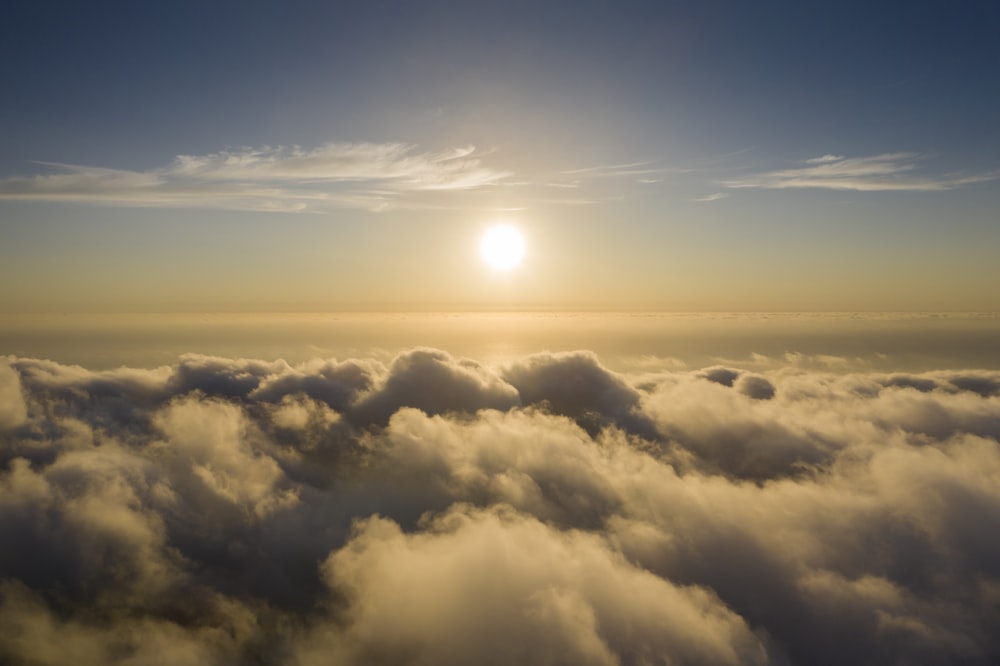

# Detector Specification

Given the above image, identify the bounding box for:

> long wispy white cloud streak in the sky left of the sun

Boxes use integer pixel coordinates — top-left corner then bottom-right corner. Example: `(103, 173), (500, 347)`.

(0, 143), (509, 212)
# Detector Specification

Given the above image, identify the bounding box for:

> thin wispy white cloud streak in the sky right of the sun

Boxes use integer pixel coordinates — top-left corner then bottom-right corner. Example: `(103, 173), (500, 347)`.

(722, 153), (1000, 192)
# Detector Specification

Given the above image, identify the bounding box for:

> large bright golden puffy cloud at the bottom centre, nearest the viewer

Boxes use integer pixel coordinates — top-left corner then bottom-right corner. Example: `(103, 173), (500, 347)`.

(302, 505), (766, 665)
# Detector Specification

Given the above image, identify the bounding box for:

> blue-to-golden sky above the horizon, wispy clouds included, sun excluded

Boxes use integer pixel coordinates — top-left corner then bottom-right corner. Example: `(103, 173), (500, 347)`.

(0, 0), (1000, 312)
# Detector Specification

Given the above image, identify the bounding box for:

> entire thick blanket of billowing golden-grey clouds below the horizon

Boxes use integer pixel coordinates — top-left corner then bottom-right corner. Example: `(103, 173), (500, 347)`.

(0, 348), (1000, 665)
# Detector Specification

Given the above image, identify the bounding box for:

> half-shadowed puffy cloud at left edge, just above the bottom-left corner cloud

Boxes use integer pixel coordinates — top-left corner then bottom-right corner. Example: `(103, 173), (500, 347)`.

(0, 445), (177, 605)
